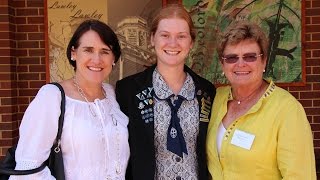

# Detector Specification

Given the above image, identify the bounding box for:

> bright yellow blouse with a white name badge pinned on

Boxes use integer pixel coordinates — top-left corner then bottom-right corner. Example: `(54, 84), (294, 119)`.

(207, 82), (316, 180)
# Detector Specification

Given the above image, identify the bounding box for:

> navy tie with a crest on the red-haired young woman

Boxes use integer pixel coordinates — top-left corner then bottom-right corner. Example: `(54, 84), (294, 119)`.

(166, 95), (188, 158)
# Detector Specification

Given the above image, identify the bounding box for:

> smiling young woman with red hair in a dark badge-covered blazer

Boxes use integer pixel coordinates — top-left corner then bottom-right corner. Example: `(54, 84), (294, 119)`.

(116, 5), (215, 180)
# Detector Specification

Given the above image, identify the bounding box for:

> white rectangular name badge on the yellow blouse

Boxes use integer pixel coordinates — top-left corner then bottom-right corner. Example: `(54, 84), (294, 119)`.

(231, 129), (255, 150)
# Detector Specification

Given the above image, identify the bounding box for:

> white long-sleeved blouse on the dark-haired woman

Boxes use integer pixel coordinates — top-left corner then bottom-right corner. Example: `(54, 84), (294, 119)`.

(10, 84), (130, 180)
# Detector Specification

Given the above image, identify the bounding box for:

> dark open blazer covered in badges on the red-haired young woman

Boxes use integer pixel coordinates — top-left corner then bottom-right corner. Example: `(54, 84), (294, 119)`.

(115, 65), (216, 180)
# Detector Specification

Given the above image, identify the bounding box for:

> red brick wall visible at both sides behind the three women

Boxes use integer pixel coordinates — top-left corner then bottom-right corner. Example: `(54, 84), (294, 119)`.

(0, 0), (320, 170)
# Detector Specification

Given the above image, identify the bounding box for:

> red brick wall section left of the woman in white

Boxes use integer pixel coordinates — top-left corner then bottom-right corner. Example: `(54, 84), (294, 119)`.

(0, 0), (46, 156)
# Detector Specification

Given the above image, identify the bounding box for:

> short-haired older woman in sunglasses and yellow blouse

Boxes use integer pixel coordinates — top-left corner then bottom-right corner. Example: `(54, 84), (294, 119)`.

(207, 21), (316, 180)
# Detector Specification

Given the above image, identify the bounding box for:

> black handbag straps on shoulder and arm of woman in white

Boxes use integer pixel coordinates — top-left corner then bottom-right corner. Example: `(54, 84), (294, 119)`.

(0, 82), (66, 175)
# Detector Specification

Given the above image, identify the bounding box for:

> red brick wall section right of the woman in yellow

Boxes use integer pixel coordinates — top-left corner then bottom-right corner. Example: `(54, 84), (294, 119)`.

(304, 0), (320, 167)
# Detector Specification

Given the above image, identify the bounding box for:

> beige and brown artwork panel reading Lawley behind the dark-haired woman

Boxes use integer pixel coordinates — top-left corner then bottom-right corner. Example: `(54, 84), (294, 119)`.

(46, 0), (162, 85)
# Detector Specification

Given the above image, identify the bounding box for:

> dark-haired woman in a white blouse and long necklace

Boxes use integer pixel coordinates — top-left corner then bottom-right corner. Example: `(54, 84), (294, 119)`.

(10, 20), (129, 180)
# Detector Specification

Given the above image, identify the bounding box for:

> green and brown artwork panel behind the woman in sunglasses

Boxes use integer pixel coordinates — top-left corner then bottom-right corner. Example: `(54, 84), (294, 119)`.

(181, 0), (305, 85)
